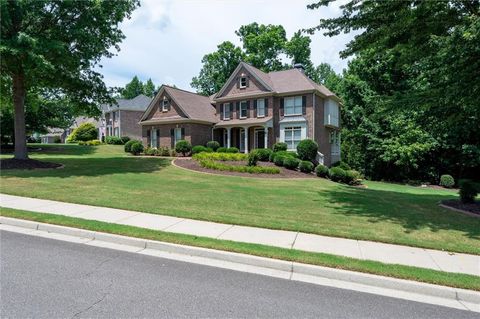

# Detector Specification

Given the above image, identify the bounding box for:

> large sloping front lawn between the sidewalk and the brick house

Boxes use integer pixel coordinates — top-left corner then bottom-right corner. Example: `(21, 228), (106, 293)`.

(0, 145), (480, 254)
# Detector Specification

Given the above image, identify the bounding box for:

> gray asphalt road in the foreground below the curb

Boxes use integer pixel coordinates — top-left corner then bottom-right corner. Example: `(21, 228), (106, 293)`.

(0, 231), (478, 319)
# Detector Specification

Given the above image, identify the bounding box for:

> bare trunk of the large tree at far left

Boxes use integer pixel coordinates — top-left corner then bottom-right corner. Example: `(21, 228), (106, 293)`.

(12, 73), (28, 159)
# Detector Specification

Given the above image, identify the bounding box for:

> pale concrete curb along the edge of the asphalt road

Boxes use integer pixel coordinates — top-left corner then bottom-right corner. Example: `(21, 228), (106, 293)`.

(0, 216), (480, 311)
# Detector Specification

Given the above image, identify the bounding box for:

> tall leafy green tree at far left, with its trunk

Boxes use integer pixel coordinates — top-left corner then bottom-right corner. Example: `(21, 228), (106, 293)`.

(0, 0), (138, 159)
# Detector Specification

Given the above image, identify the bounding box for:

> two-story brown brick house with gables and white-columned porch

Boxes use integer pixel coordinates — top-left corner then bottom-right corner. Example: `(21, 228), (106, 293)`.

(140, 62), (340, 165)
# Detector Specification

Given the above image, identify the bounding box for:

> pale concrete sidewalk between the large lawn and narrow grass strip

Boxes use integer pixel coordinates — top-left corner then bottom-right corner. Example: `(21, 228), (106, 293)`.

(0, 194), (480, 276)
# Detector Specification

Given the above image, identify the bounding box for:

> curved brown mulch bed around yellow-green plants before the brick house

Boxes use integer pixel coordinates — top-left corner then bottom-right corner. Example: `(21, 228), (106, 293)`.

(175, 158), (316, 178)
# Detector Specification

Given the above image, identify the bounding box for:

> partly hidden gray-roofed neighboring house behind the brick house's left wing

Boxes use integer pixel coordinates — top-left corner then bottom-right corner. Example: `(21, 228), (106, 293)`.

(99, 94), (152, 140)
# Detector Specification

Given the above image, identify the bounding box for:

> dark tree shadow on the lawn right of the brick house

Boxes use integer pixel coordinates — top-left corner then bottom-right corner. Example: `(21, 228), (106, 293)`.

(319, 186), (480, 239)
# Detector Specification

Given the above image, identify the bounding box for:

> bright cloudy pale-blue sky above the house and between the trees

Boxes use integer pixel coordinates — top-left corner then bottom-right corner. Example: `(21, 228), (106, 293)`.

(99, 0), (353, 91)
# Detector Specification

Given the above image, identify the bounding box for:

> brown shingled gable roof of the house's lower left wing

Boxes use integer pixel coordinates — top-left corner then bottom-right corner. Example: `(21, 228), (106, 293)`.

(140, 85), (218, 123)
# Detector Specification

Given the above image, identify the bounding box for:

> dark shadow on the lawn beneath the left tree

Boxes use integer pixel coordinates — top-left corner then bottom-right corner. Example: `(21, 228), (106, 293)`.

(2, 156), (170, 179)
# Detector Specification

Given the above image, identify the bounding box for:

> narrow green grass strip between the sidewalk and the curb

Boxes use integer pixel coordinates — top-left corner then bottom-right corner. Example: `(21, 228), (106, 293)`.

(0, 208), (480, 291)
